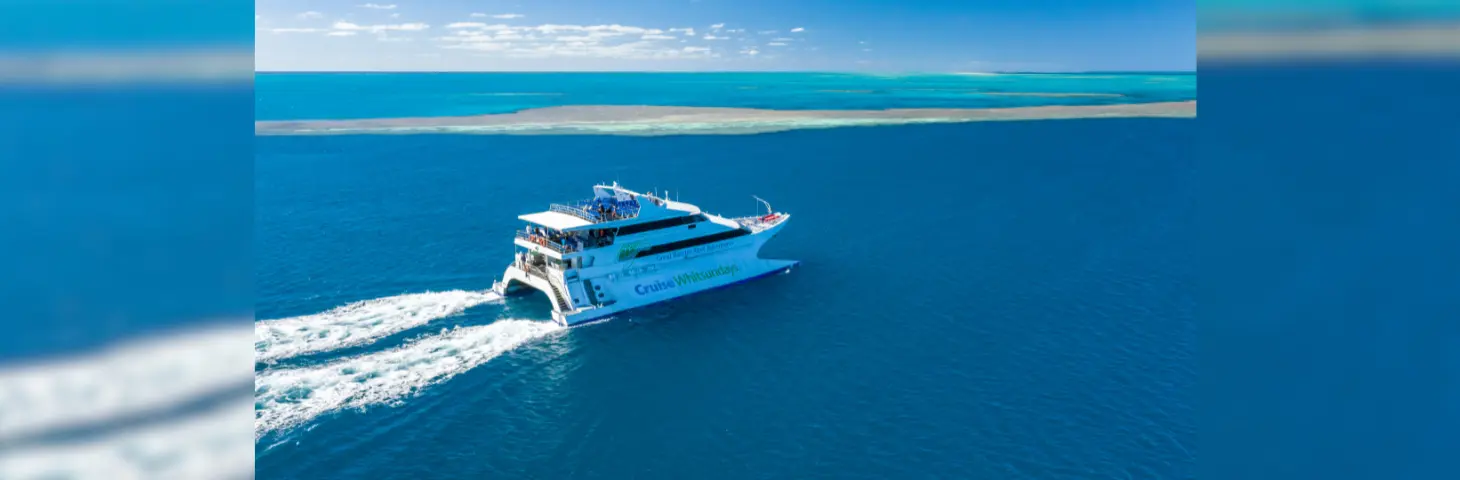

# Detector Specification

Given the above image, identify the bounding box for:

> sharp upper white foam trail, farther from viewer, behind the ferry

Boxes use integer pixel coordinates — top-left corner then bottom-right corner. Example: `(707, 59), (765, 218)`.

(254, 290), (502, 362)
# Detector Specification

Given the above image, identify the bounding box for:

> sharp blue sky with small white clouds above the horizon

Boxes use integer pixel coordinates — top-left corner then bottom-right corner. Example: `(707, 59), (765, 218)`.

(254, 0), (1196, 71)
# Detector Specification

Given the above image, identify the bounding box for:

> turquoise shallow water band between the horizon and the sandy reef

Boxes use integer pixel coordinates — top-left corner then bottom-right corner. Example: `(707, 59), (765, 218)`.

(254, 73), (1196, 120)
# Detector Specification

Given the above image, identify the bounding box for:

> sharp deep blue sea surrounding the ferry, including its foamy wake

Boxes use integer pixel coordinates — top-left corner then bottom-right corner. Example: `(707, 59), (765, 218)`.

(254, 71), (1197, 479)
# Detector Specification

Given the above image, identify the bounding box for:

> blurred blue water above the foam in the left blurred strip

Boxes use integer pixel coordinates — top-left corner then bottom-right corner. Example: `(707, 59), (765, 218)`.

(0, 83), (254, 362)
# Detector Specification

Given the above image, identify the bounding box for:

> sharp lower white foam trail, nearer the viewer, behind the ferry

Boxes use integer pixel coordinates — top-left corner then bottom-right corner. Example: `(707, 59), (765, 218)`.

(254, 320), (564, 436)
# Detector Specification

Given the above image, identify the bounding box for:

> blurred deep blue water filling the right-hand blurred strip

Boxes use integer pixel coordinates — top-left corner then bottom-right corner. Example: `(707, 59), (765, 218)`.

(1190, 58), (1460, 479)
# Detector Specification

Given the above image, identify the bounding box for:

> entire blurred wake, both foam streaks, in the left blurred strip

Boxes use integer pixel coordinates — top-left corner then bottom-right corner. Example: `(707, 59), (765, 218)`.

(0, 318), (254, 479)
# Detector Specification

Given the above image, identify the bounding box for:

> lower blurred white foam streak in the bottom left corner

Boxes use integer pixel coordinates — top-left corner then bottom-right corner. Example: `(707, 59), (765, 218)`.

(0, 398), (254, 479)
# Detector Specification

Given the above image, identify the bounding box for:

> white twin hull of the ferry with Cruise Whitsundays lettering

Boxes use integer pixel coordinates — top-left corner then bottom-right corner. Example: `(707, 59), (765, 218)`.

(502, 217), (796, 325)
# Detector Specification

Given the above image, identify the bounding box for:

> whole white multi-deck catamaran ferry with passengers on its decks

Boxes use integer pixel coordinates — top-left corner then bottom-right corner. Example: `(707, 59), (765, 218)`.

(493, 182), (797, 325)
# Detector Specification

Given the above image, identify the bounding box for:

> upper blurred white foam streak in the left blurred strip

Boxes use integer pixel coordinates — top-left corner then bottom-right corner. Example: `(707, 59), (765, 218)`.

(0, 320), (253, 444)
